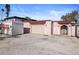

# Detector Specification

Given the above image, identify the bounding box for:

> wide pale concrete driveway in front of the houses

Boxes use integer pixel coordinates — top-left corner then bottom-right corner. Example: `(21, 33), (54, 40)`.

(0, 34), (79, 55)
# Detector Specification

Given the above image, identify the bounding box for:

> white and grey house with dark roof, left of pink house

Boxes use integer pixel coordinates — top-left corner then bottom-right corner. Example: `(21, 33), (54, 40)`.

(2, 16), (24, 35)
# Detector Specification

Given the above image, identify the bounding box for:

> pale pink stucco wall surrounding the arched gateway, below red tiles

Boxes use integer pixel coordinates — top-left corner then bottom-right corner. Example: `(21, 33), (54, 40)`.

(52, 22), (75, 36)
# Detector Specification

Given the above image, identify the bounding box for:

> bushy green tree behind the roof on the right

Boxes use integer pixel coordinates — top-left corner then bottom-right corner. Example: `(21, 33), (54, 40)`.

(61, 10), (78, 21)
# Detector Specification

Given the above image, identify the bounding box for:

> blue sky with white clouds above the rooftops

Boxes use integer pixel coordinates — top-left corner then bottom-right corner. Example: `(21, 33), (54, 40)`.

(0, 4), (79, 20)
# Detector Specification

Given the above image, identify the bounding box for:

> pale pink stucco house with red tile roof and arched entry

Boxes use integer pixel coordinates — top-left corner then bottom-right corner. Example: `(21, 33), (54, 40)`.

(24, 20), (79, 36)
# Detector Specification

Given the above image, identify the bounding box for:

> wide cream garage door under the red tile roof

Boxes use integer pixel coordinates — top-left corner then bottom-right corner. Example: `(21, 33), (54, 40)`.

(31, 24), (44, 34)
